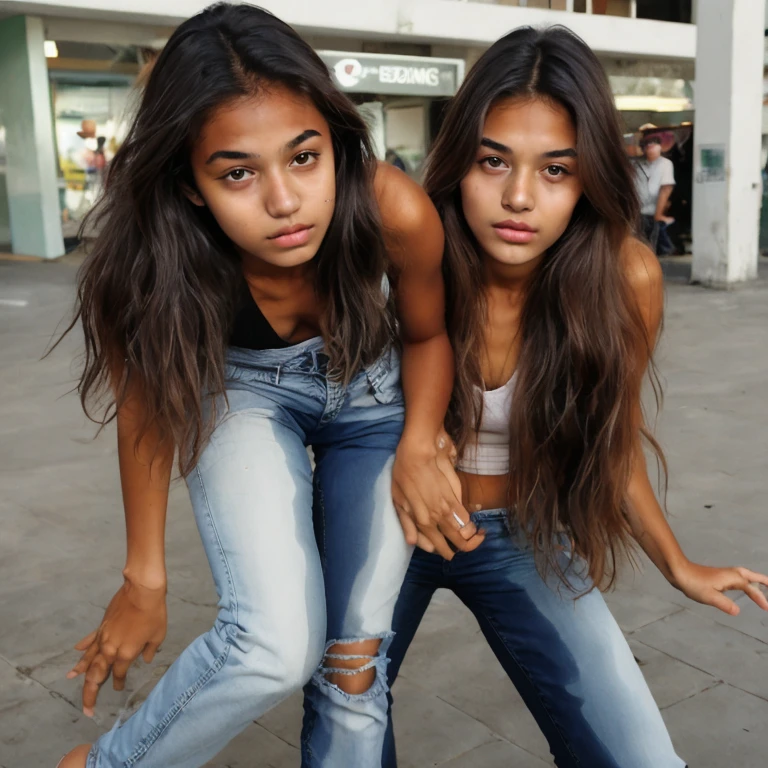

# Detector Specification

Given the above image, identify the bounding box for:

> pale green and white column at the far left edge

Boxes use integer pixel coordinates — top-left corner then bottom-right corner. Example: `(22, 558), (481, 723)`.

(0, 16), (64, 258)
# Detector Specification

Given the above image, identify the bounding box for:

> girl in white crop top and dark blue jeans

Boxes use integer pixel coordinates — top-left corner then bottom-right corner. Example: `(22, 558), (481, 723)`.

(383, 28), (768, 768)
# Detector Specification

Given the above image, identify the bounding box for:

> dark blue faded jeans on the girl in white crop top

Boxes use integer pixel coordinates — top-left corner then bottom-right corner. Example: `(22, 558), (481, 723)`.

(382, 510), (684, 768)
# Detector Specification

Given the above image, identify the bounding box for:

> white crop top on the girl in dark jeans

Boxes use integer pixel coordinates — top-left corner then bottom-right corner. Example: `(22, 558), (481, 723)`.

(456, 371), (517, 475)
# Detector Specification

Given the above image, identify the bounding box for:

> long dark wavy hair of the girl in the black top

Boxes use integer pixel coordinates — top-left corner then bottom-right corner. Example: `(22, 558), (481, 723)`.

(59, 3), (393, 474)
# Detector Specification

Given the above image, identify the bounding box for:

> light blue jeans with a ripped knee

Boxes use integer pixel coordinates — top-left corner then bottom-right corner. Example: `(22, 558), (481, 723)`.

(87, 338), (411, 768)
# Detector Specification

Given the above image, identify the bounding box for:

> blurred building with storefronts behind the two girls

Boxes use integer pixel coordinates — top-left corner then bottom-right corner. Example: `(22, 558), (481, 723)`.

(0, 0), (768, 284)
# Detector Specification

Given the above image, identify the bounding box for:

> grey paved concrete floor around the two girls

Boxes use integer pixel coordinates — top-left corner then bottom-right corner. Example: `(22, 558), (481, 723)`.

(0, 261), (768, 768)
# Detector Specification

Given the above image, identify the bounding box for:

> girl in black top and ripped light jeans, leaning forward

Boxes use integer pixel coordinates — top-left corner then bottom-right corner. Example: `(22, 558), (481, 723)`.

(55, 4), (482, 768)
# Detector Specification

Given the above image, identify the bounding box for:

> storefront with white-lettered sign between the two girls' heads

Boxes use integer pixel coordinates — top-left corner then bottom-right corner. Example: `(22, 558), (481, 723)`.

(318, 51), (464, 177)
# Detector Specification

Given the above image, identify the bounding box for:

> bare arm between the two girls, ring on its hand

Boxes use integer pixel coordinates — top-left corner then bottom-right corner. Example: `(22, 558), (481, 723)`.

(376, 164), (482, 559)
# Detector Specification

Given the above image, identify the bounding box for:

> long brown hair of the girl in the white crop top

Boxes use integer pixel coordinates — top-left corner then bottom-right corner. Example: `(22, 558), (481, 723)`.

(432, 27), (663, 586)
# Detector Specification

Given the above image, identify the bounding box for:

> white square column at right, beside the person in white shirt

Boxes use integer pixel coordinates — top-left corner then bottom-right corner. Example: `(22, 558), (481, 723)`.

(692, 0), (765, 287)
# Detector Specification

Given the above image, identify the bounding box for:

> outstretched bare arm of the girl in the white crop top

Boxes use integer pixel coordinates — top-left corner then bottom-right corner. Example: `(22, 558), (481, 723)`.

(622, 238), (768, 615)
